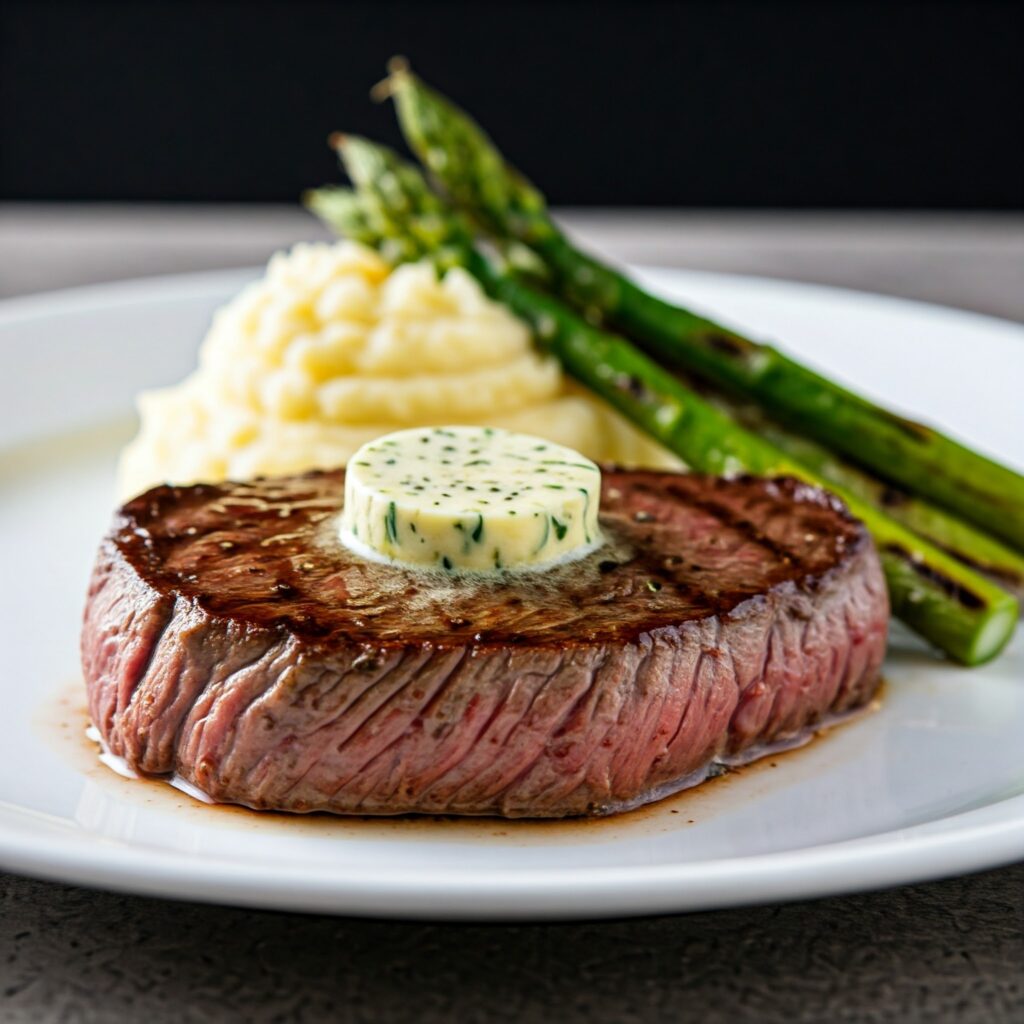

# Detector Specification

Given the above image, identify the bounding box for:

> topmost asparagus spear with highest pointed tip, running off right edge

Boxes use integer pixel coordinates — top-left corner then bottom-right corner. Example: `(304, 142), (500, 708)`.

(389, 62), (1024, 551)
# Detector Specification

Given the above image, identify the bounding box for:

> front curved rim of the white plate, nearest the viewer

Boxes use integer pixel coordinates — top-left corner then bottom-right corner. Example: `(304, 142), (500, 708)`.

(0, 794), (1024, 921)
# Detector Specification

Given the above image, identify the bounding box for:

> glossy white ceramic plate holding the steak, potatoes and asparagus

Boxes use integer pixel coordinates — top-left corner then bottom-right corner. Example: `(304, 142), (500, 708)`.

(0, 271), (1024, 919)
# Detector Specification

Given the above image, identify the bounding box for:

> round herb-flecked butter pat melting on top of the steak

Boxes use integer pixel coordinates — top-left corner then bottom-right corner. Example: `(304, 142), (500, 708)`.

(340, 427), (602, 572)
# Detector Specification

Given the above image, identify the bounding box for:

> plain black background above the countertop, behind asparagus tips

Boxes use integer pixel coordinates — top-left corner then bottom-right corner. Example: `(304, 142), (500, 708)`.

(0, 0), (1024, 209)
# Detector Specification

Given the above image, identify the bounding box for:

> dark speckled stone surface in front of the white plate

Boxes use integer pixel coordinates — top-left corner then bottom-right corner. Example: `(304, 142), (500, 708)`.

(0, 864), (1024, 1024)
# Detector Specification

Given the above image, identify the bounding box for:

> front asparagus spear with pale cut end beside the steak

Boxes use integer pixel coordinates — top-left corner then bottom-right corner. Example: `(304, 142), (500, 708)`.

(307, 137), (1018, 665)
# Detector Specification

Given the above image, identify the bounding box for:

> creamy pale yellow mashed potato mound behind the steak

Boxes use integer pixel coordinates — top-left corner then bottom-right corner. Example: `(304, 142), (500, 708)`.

(120, 242), (678, 498)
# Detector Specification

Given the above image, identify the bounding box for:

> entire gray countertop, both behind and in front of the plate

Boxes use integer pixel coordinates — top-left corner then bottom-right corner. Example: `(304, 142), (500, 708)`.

(0, 205), (1024, 1024)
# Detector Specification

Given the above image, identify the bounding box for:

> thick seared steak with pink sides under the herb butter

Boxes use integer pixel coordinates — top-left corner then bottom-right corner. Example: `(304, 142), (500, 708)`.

(82, 469), (889, 817)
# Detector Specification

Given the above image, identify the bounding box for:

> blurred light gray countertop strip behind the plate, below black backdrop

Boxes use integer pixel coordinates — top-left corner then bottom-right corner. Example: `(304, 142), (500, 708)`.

(6, 204), (1024, 321)
